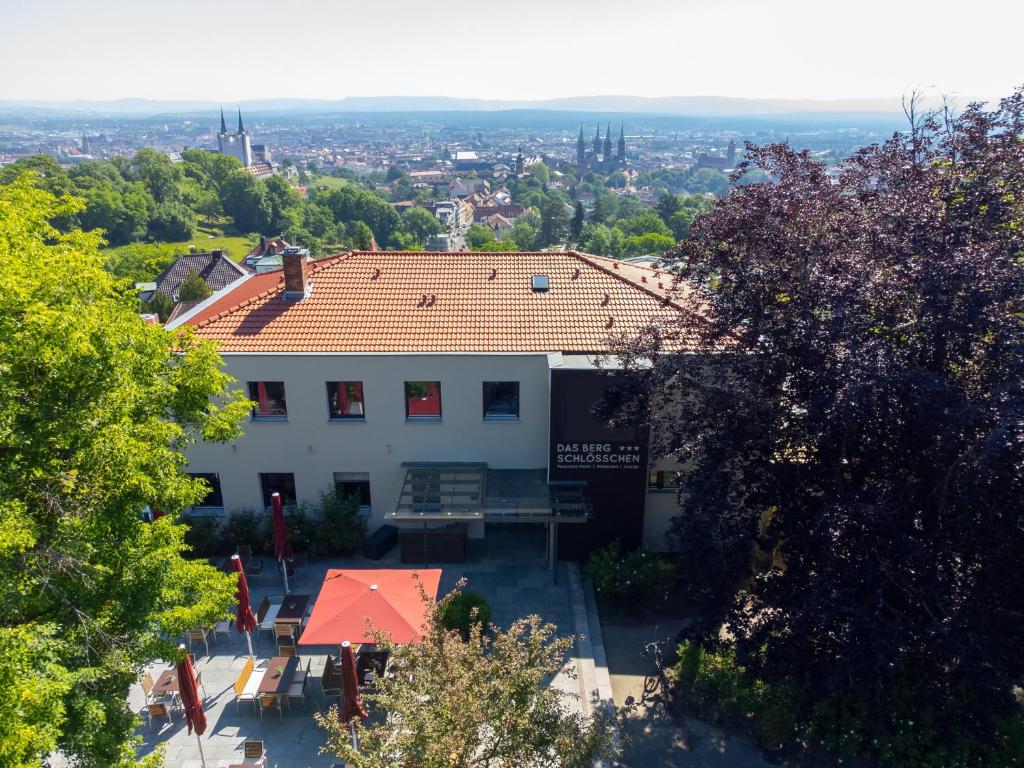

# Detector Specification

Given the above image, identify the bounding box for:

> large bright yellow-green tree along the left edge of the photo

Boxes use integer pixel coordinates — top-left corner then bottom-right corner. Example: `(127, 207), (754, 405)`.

(0, 178), (249, 768)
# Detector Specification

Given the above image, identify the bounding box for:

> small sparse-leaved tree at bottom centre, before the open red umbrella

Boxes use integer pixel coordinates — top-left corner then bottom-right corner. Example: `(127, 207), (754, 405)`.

(316, 583), (613, 768)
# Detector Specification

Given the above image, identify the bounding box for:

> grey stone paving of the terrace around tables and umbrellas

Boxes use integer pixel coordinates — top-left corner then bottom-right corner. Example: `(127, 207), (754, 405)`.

(129, 527), (594, 768)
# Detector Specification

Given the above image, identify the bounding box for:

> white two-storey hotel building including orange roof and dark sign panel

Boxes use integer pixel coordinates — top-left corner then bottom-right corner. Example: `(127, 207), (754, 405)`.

(174, 252), (696, 557)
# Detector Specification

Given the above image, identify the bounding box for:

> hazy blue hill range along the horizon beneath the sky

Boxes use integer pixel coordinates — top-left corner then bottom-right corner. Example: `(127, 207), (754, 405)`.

(0, 95), (946, 117)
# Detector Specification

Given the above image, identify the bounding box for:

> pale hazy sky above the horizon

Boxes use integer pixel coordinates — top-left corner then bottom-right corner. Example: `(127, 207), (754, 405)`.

(0, 0), (1024, 103)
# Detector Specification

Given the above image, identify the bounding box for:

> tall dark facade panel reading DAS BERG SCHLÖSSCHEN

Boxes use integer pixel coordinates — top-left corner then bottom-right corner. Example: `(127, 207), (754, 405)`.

(548, 369), (647, 559)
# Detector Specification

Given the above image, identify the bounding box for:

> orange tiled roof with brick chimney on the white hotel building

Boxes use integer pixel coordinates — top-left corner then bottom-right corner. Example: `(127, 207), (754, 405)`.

(186, 251), (696, 352)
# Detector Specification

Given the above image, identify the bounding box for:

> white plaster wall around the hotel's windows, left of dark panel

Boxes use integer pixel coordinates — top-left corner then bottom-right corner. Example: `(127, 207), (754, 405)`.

(186, 353), (550, 530)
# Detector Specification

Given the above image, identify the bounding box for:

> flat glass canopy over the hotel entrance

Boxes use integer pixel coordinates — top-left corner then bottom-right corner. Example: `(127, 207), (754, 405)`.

(388, 463), (590, 522)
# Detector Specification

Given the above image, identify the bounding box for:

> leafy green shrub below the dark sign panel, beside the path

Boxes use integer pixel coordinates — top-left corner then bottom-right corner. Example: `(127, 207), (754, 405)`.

(585, 542), (676, 604)
